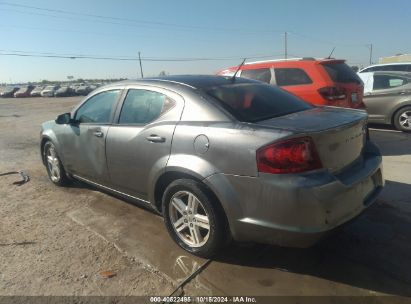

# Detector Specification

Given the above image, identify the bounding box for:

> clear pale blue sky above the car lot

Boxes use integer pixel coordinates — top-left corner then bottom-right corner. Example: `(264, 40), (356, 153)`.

(0, 0), (411, 83)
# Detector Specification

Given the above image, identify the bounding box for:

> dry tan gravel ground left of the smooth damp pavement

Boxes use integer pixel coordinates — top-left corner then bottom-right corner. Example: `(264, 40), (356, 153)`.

(0, 97), (173, 295)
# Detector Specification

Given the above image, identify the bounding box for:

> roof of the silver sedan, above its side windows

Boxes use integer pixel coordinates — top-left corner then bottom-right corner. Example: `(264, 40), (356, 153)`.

(116, 75), (260, 89)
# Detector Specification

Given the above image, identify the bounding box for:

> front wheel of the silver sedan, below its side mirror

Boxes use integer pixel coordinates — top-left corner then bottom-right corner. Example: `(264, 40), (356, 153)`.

(43, 141), (70, 186)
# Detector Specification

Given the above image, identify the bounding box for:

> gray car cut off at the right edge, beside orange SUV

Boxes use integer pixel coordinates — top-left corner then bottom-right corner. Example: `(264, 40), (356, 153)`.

(359, 71), (411, 132)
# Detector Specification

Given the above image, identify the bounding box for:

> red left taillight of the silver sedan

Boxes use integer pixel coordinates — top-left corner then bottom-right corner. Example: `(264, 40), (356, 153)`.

(257, 137), (322, 174)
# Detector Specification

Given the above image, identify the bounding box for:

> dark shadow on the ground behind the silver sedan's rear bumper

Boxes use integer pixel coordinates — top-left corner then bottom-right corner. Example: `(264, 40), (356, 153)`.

(217, 182), (411, 296)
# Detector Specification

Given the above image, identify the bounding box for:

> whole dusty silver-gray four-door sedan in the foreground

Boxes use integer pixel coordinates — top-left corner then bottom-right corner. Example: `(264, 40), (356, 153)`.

(41, 76), (384, 257)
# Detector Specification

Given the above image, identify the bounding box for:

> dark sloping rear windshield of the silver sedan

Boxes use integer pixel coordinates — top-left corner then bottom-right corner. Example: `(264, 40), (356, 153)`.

(204, 83), (313, 122)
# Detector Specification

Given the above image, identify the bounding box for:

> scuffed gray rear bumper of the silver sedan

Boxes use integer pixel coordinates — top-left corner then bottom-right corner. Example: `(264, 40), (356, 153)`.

(205, 142), (384, 247)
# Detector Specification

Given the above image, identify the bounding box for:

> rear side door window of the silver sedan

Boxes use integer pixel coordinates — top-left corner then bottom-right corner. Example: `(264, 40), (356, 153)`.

(119, 89), (175, 124)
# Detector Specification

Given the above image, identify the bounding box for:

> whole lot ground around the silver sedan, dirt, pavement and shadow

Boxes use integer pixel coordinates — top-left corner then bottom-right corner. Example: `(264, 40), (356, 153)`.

(0, 97), (411, 296)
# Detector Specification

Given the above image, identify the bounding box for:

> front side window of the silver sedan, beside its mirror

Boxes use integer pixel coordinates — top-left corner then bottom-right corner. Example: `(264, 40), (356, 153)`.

(74, 90), (121, 124)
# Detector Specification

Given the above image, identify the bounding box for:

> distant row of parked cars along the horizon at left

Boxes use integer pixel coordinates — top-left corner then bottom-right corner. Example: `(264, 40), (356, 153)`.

(0, 83), (98, 97)
